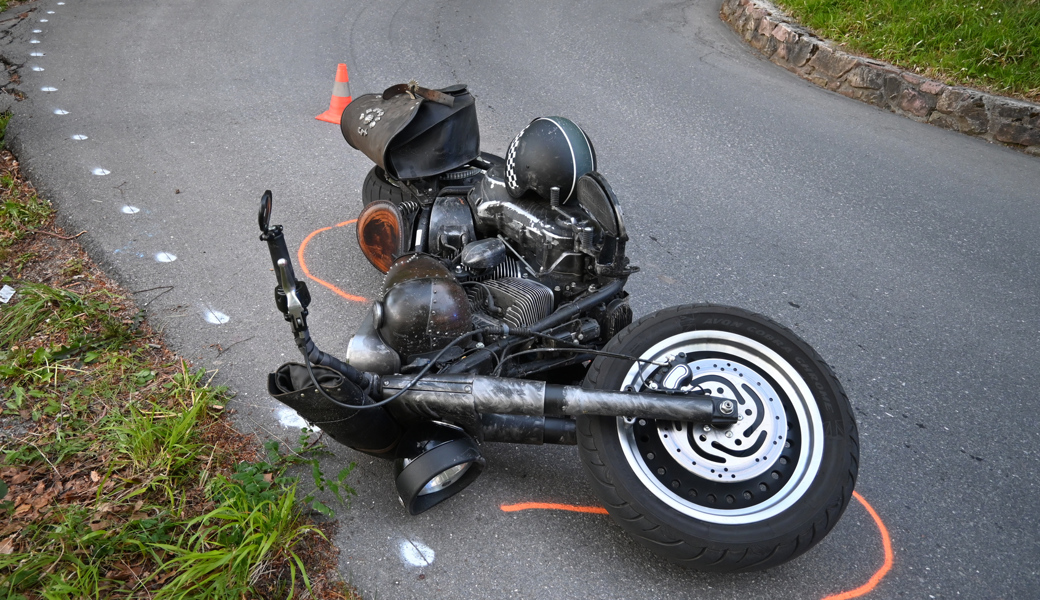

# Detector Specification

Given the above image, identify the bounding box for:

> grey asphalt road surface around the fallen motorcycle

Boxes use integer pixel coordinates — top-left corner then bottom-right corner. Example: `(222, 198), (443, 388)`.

(3, 0), (1040, 599)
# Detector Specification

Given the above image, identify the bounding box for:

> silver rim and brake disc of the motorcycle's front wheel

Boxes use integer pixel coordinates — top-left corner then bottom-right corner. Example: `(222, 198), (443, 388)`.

(618, 331), (824, 525)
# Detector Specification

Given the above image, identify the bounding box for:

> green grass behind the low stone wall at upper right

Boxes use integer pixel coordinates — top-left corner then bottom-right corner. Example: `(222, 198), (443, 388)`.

(777, 0), (1040, 101)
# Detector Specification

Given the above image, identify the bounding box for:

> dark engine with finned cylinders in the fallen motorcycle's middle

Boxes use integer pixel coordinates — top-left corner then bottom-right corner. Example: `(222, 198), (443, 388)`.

(347, 163), (636, 373)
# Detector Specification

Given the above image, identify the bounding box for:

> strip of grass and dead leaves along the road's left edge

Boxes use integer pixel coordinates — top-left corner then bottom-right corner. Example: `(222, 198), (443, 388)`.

(0, 111), (356, 600)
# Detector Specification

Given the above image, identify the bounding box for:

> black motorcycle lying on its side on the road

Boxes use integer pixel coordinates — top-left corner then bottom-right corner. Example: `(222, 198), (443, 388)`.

(259, 82), (859, 572)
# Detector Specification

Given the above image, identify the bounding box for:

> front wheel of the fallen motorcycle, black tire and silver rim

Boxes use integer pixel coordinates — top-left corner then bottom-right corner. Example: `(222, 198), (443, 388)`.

(577, 305), (859, 572)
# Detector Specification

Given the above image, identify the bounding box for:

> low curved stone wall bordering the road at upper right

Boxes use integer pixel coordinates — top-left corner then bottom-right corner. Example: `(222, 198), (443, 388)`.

(721, 0), (1040, 156)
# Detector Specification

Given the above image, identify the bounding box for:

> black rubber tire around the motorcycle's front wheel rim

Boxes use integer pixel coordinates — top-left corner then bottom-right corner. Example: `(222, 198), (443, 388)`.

(577, 305), (859, 573)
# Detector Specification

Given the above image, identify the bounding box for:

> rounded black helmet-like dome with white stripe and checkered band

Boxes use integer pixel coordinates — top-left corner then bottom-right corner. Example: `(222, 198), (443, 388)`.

(505, 116), (596, 202)
